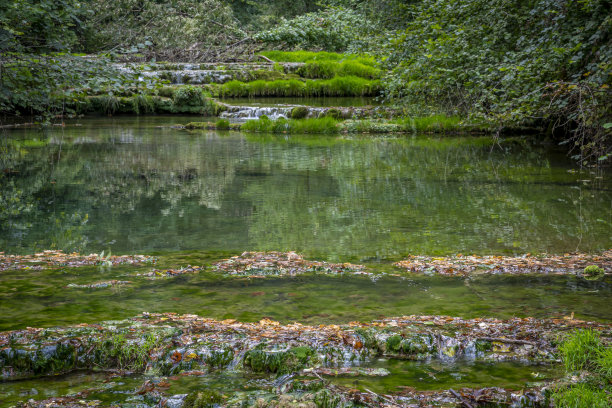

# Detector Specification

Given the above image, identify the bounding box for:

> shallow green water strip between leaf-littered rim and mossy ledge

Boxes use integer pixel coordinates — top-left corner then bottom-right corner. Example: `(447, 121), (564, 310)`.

(0, 262), (612, 330)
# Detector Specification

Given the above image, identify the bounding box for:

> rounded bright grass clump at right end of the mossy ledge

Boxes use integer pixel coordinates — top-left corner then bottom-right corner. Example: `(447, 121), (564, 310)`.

(559, 329), (603, 371)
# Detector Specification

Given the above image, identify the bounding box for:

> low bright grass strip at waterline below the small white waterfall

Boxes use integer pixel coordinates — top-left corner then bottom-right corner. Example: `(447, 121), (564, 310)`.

(240, 116), (339, 134)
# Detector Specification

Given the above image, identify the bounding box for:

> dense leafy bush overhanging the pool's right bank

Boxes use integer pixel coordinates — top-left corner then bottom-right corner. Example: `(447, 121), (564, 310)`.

(388, 0), (612, 163)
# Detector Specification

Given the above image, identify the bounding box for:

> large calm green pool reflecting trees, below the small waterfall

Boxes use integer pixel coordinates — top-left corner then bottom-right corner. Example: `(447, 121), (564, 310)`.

(0, 117), (612, 261)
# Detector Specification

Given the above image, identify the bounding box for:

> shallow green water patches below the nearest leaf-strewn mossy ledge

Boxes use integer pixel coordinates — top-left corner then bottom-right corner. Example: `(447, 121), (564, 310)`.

(0, 359), (562, 406)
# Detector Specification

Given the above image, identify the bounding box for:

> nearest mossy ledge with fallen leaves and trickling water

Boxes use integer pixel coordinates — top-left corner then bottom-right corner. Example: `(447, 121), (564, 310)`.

(0, 313), (612, 380)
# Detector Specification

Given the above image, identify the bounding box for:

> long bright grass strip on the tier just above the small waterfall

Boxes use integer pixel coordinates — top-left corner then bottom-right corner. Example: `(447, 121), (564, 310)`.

(219, 76), (381, 98)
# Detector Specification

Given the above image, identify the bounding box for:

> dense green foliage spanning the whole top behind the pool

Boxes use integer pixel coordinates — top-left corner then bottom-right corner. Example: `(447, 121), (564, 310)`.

(0, 0), (612, 162)
